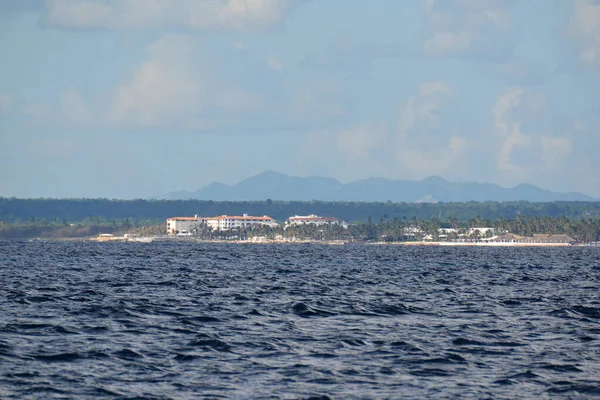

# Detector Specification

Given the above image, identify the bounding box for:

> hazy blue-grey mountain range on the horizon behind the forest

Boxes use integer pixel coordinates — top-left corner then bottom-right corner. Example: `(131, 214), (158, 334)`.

(160, 171), (595, 202)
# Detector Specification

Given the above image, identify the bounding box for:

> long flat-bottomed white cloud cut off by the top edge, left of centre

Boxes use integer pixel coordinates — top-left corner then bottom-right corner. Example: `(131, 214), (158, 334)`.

(45, 0), (298, 31)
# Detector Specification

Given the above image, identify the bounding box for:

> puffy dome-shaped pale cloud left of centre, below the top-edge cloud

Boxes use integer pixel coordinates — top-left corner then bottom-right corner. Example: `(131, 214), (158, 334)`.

(111, 34), (259, 130)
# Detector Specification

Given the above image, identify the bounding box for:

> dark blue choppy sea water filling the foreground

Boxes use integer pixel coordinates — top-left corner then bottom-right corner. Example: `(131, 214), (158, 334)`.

(0, 242), (600, 399)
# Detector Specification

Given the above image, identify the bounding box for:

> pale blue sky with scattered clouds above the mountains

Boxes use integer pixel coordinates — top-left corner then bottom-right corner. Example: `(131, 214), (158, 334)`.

(0, 0), (600, 198)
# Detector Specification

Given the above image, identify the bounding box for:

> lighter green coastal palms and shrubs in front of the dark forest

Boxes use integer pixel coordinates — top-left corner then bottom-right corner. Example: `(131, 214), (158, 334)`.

(0, 216), (600, 243)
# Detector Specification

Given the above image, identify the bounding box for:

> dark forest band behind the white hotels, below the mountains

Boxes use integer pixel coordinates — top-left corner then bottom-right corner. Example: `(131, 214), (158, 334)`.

(0, 197), (600, 225)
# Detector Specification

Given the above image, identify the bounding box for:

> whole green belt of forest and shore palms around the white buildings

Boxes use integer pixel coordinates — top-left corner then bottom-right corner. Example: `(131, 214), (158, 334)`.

(0, 198), (600, 242)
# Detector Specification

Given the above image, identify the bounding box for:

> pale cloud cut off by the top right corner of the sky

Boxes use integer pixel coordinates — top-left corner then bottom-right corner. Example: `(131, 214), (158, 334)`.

(571, 0), (600, 66)
